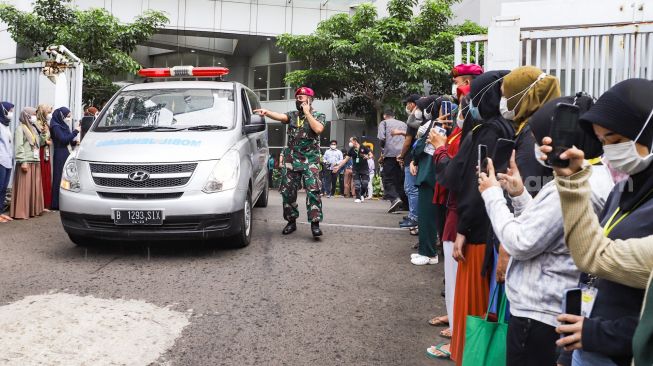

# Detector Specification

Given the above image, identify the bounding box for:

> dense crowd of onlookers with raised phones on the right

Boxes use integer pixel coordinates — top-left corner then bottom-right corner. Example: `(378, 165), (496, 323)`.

(364, 64), (653, 366)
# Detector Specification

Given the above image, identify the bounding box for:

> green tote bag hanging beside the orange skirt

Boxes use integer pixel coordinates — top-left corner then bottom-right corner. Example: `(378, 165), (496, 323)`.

(463, 285), (508, 366)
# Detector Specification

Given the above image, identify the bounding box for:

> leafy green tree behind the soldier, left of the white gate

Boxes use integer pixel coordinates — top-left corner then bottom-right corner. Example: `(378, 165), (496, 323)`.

(277, 0), (486, 122)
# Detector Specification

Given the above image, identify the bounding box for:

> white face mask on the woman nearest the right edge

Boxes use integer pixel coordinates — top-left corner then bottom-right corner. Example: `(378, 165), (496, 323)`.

(603, 106), (653, 175)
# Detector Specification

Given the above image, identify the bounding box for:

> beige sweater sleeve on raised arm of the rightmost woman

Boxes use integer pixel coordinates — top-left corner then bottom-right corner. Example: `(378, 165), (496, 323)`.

(556, 166), (653, 289)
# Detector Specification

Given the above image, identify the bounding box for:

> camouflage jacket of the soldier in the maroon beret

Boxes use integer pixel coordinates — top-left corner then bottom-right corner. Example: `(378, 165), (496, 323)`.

(284, 111), (326, 170)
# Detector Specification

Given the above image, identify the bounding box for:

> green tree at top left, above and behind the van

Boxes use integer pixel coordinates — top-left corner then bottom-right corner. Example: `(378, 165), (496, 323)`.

(0, 0), (168, 105)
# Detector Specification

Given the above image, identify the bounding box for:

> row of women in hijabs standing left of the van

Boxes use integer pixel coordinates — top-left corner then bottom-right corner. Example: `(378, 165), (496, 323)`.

(0, 102), (98, 223)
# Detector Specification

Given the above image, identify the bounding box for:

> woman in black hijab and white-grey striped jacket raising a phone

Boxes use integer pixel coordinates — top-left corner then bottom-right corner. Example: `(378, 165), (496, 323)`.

(479, 96), (613, 366)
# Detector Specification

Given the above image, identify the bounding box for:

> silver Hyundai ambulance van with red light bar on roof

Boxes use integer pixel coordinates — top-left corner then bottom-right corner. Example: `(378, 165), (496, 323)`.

(60, 67), (269, 247)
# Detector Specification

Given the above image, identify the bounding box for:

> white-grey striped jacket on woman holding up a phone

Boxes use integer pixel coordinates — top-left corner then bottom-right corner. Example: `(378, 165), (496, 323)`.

(482, 166), (613, 327)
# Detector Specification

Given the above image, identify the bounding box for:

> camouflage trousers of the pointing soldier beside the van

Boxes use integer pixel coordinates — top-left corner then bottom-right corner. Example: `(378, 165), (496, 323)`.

(279, 164), (323, 222)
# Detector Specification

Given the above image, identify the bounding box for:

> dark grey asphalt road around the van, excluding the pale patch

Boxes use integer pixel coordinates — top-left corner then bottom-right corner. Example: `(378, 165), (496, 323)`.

(0, 191), (451, 365)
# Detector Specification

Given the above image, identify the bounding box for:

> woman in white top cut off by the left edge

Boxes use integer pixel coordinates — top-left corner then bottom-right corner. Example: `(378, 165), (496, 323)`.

(0, 102), (14, 222)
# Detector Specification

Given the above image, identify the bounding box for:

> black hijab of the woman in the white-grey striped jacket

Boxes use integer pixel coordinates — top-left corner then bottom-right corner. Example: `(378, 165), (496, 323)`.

(528, 95), (603, 159)
